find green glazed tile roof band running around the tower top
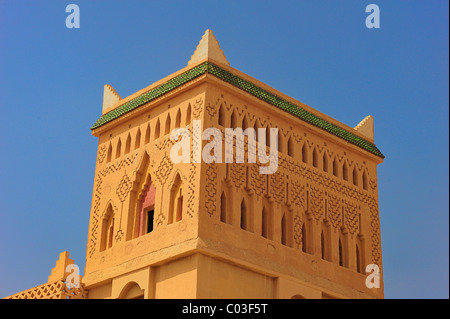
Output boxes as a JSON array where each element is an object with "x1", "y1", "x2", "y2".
[{"x1": 91, "y1": 62, "x2": 384, "y2": 158}]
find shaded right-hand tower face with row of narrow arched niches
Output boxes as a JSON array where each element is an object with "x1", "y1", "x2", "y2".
[{"x1": 199, "y1": 85, "x2": 383, "y2": 297}]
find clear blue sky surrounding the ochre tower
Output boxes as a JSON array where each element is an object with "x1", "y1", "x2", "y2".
[{"x1": 0, "y1": 0, "x2": 449, "y2": 298}]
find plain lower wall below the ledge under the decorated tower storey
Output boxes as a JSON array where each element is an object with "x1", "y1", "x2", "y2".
[{"x1": 86, "y1": 253, "x2": 360, "y2": 299}]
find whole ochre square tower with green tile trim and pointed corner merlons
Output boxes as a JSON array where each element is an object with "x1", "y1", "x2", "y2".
[{"x1": 83, "y1": 30, "x2": 384, "y2": 298}]
